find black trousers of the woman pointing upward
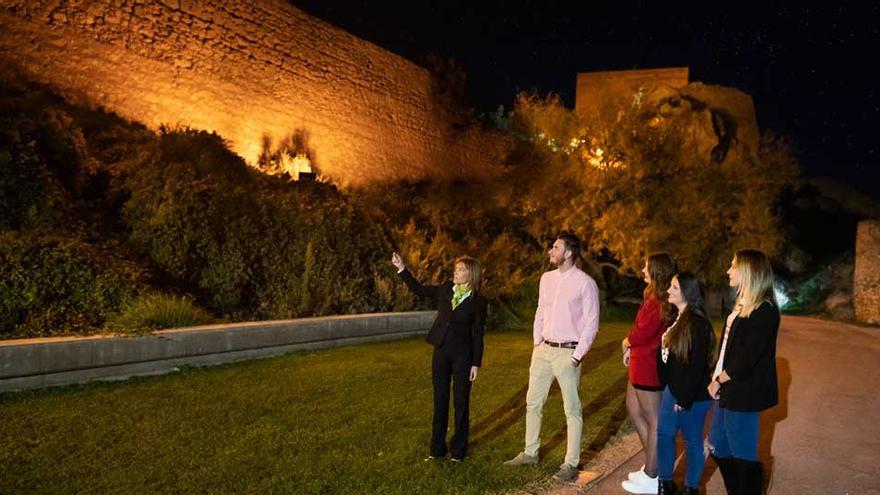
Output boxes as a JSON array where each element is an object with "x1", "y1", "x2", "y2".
[{"x1": 431, "y1": 343, "x2": 471, "y2": 459}]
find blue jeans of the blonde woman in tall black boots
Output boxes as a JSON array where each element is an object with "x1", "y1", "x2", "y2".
[{"x1": 709, "y1": 401, "x2": 761, "y2": 462}]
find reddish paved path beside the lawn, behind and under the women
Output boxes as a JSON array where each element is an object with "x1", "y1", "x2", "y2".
[{"x1": 559, "y1": 316, "x2": 880, "y2": 495}]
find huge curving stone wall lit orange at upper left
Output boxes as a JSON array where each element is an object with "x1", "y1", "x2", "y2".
[{"x1": 0, "y1": 0, "x2": 491, "y2": 185}]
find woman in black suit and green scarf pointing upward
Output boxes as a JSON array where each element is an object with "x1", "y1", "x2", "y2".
[{"x1": 391, "y1": 253, "x2": 487, "y2": 462}]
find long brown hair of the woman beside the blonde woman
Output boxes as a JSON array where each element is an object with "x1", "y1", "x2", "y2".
[{"x1": 663, "y1": 272, "x2": 715, "y2": 367}]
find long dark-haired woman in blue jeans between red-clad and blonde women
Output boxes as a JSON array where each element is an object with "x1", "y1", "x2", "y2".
[{"x1": 657, "y1": 272, "x2": 715, "y2": 495}]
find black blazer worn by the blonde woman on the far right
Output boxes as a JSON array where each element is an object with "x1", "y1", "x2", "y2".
[{"x1": 719, "y1": 301, "x2": 779, "y2": 412}]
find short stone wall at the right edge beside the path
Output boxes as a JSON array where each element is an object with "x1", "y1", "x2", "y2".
[{"x1": 853, "y1": 220, "x2": 880, "y2": 325}]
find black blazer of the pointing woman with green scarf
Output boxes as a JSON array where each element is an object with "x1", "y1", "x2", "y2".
[{"x1": 399, "y1": 269, "x2": 487, "y2": 366}]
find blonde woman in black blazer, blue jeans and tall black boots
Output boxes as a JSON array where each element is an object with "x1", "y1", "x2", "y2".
[{"x1": 708, "y1": 249, "x2": 780, "y2": 495}]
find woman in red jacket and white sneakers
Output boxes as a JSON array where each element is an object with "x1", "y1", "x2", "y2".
[{"x1": 621, "y1": 253, "x2": 677, "y2": 493}]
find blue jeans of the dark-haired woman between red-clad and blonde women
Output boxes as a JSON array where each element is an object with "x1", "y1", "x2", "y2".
[{"x1": 657, "y1": 387, "x2": 712, "y2": 488}]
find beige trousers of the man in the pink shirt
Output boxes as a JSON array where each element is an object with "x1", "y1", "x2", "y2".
[{"x1": 525, "y1": 344, "x2": 584, "y2": 467}]
